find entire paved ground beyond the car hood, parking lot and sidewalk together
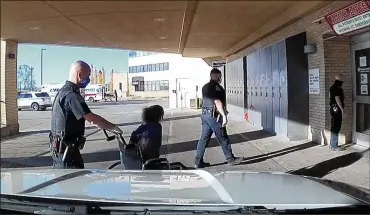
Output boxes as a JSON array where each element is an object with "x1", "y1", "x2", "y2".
[{"x1": 1, "y1": 100, "x2": 370, "y2": 188}]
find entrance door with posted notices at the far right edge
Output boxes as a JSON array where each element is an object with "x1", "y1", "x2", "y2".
[{"x1": 351, "y1": 32, "x2": 370, "y2": 147}]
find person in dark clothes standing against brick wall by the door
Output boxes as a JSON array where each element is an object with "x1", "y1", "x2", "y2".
[{"x1": 329, "y1": 75, "x2": 344, "y2": 151}]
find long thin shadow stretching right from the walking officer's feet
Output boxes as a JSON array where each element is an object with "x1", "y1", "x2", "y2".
[{"x1": 211, "y1": 142, "x2": 317, "y2": 166}]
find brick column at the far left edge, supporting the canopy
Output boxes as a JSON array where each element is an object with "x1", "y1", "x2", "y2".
[{"x1": 0, "y1": 40, "x2": 19, "y2": 137}]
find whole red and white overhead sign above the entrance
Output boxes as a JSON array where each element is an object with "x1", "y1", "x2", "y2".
[{"x1": 325, "y1": 0, "x2": 370, "y2": 35}]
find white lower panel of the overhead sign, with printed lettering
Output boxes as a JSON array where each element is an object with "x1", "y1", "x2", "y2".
[{"x1": 333, "y1": 11, "x2": 370, "y2": 34}]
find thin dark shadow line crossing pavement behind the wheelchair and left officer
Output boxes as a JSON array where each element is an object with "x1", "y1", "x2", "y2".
[{"x1": 1, "y1": 114, "x2": 200, "y2": 141}]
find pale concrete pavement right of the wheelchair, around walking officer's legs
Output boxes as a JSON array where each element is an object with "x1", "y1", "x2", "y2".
[{"x1": 166, "y1": 112, "x2": 370, "y2": 188}]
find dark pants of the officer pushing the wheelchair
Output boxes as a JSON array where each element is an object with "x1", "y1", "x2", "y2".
[{"x1": 51, "y1": 143, "x2": 84, "y2": 169}]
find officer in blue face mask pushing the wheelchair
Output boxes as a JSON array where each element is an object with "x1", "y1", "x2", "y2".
[{"x1": 49, "y1": 61, "x2": 123, "y2": 169}]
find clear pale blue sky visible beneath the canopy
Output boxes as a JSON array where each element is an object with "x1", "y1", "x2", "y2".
[{"x1": 17, "y1": 44, "x2": 128, "y2": 86}]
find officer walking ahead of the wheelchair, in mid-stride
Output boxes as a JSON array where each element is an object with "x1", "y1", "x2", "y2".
[{"x1": 195, "y1": 68, "x2": 243, "y2": 168}]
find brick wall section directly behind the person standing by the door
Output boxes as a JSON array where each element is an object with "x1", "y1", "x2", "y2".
[{"x1": 324, "y1": 37, "x2": 352, "y2": 143}]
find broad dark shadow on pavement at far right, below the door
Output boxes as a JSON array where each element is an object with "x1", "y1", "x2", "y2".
[{"x1": 287, "y1": 149, "x2": 370, "y2": 178}]
